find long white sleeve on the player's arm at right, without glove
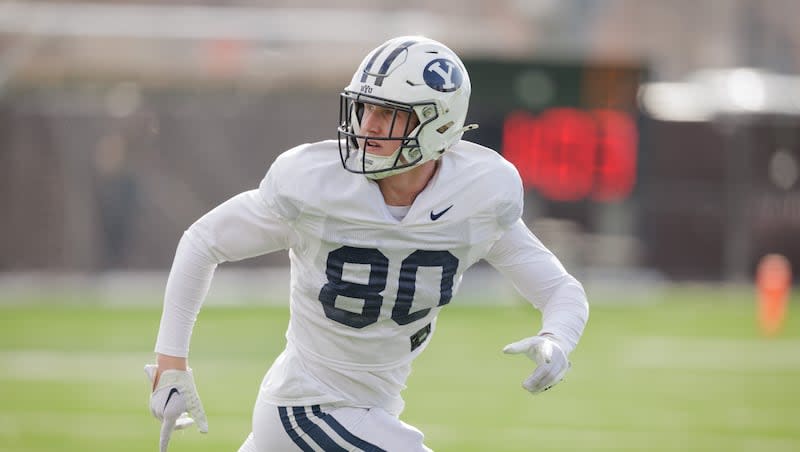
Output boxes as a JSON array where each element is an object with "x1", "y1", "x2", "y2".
[{"x1": 486, "y1": 219, "x2": 589, "y2": 354}]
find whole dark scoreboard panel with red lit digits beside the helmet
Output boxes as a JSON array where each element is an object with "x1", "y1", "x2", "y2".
[{"x1": 465, "y1": 60, "x2": 644, "y2": 202}]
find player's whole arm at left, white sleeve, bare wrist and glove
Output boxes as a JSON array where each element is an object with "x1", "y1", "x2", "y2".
[{"x1": 145, "y1": 190, "x2": 292, "y2": 452}]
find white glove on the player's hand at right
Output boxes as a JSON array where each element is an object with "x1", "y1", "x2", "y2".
[{"x1": 503, "y1": 335, "x2": 570, "y2": 394}]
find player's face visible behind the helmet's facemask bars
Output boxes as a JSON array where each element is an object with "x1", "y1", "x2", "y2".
[{"x1": 358, "y1": 104, "x2": 419, "y2": 156}]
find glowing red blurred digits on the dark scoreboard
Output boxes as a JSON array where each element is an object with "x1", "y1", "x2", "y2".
[{"x1": 501, "y1": 107, "x2": 638, "y2": 201}]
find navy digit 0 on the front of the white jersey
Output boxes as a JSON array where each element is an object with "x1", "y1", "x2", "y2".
[{"x1": 392, "y1": 250, "x2": 458, "y2": 325}]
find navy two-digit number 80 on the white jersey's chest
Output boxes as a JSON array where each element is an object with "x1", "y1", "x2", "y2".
[{"x1": 319, "y1": 246, "x2": 458, "y2": 328}]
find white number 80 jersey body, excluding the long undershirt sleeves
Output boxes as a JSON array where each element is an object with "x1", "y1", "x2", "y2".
[{"x1": 259, "y1": 141, "x2": 522, "y2": 410}]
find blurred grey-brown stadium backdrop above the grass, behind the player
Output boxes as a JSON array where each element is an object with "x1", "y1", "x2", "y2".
[{"x1": 0, "y1": 0, "x2": 800, "y2": 296}]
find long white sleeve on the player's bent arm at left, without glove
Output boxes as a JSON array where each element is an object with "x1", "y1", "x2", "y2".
[{"x1": 155, "y1": 190, "x2": 293, "y2": 357}]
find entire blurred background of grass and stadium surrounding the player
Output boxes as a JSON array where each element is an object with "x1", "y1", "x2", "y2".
[{"x1": 0, "y1": 0, "x2": 800, "y2": 452}]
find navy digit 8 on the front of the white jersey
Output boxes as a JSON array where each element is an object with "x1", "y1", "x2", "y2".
[{"x1": 319, "y1": 246, "x2": 389, "y2": 328}]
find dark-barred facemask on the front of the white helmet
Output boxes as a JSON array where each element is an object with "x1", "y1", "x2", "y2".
[{"x1": 338, "y1": 91, "x2": 436, "y2": 179}]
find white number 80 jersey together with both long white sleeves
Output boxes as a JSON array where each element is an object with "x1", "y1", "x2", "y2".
[{"x1": 156, "y1": 140, "x2": 585, "y2": 414}]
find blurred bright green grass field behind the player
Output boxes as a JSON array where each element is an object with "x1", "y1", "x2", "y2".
[{"x1": 0, "y1": 288, "x2": 800, "y2": 452}]
